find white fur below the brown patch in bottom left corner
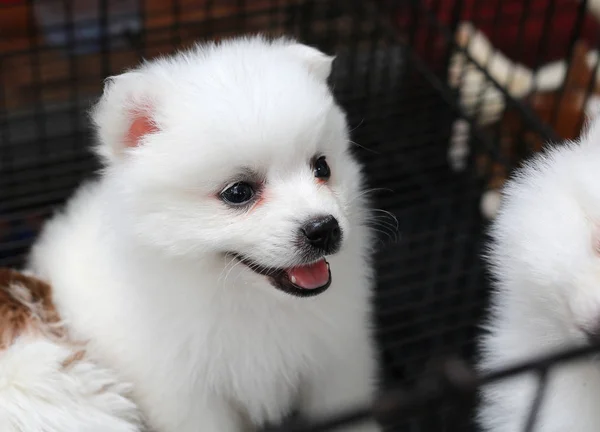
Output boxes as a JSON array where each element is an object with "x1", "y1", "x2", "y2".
[{"x1": 0, "y1": 336, "x2": 142, "y2": 432}]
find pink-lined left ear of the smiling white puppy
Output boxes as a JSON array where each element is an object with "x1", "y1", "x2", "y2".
[{"x1": 92, "y1": 72, "x2": 160, "y2": 163}]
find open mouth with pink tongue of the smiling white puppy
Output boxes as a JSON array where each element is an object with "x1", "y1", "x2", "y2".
[{"x1": 235, "y1": 255, "x2": 331, "y2": 297}]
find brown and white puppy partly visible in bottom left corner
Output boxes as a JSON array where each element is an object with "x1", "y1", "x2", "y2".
[{"x1": 0, "y1": 269, "x2": 141, "y2": 432}]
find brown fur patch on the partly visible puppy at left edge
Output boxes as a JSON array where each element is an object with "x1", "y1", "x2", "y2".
[{"x1": 0, "y1": 269, "x2": 66, "y2": 350}]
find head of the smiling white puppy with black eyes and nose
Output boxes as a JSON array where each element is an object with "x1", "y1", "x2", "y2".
[{"x1": 93, "y1": 38, "x2": 361, "y2": 295}]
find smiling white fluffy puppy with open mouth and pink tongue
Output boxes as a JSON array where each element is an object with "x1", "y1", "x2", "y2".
[{"x1": 30, "y1": 37, "x2": 377, "y2": 432}]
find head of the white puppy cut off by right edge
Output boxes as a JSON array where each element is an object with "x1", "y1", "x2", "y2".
[{"x1": 490, "y1": 121, "x2": 600, "y2": 343}]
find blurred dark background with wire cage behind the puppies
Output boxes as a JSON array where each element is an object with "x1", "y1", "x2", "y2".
[{"x1": 0, "y1": 0, "x2": 600, "y2": 432}]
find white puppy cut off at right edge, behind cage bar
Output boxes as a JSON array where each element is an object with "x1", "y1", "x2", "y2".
[{"x1": 479, "y1": 120, "x2": 600, "y2": 432}]
